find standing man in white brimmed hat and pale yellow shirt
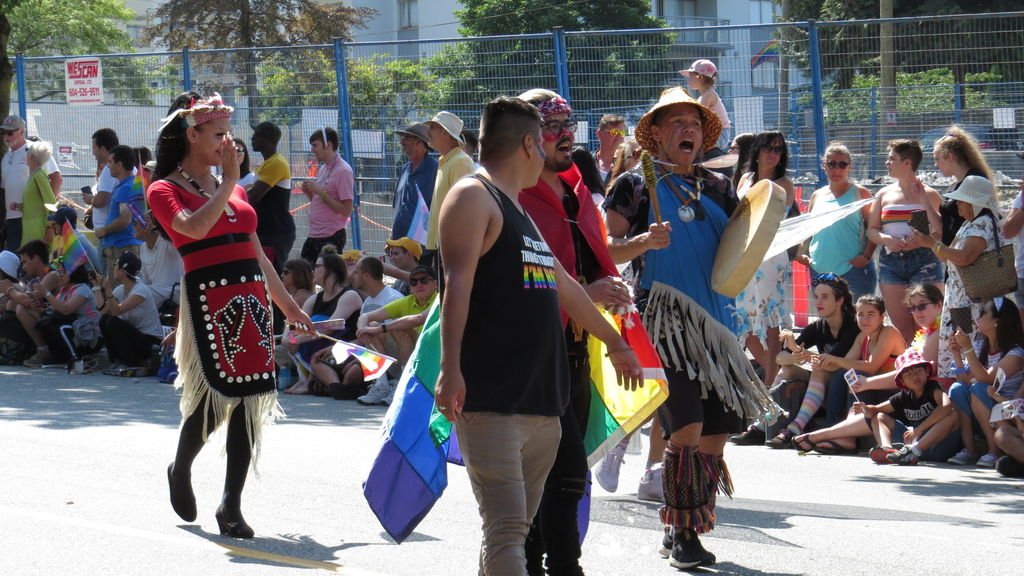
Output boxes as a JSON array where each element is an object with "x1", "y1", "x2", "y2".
[{"x1": 427, "y1": 112, "x2": 473, "y2": 265}]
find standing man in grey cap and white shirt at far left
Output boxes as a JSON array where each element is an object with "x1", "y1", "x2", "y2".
[{"x1": 0, "y1": 115, "x2": 62, "y2": 251}]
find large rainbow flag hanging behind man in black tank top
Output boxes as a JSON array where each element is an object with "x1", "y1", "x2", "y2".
[{"x1": 362, "y1": 302, "x2": 668, "y2": 542}]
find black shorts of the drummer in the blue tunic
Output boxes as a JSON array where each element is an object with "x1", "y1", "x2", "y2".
[{"x1": 657, "y1": 366, "x2": 744, "y2": 440}]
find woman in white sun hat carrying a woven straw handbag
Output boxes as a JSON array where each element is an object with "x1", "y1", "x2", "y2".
[{"x1": 913, "y1": 175, "x2": 1017, "y2": 378}]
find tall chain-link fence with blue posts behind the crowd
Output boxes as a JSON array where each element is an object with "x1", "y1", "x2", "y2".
[{"x1": 8, "y1": 12, "x2": 1024, "y2": 254}]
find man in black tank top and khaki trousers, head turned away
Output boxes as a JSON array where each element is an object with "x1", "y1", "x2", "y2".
[{"x1": 435, "y1": 97, "x2": 641, "y2": 575}]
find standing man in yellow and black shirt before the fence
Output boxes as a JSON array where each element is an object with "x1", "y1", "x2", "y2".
[{"x1": 249, "y1": 122, "x2": 294, "y2": 274}]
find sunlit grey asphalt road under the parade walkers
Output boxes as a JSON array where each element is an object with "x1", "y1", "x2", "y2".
[{"x1": 0, "y1": 368, "x2": 1024, "y2": 576}]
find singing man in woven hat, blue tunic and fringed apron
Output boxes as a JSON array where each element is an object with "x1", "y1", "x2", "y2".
[{"x1": 605, "y1": 87, "x2": 773, "y2": 569}]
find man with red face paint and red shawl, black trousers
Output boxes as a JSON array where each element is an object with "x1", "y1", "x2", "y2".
[{"x1": 519, "y1": 89, "x2": 633, "y2": 574}]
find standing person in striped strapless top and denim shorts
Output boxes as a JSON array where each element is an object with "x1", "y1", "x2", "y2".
[{"x1": 867, "y1": 140, "x2": 945, "y2": 342}]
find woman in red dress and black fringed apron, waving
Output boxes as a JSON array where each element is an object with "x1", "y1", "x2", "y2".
[{"x1": 146, "y1": 92, "x2": 311, "y2": 538}]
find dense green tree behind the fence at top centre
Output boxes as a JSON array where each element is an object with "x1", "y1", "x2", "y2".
[{"x1": 427, "y1": 0, "x2": 674, "y2": 115}]
